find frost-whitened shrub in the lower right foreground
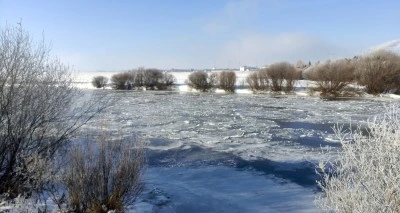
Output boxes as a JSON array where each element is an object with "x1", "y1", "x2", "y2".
[{"x1": 317, "y1": 106, "x2": 400, "y2": 212}]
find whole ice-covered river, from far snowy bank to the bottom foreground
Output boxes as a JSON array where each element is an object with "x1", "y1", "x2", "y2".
[{"x1": 80, "y1": 90, "x2": 390, "y2": 212}]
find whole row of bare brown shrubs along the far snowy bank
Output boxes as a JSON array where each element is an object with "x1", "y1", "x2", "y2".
[{"x1": 92, "y1": 50, "x2": 400, "y2": 98}]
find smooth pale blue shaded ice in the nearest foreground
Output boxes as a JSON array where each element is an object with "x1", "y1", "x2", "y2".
[{"x1": 132, "y1": 166, "x2": 318, "y2": 213}]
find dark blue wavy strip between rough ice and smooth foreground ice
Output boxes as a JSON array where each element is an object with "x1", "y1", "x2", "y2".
[{"x1": 148, "y1": 146, "x2": 318, "y2": 189}]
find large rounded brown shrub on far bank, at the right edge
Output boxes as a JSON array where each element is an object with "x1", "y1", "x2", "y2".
[{"x1": 356, "y1": 51, "x2": 400, "y2": 95}]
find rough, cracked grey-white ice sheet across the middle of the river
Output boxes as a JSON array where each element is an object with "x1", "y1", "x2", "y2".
[{"x1": 82, "y1": 91, "x2": 388, "y2": 161}]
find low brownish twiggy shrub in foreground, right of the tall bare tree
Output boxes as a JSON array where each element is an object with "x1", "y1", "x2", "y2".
[{"x1": 62, "y1": 135, "x2": 144, "y2": 213}]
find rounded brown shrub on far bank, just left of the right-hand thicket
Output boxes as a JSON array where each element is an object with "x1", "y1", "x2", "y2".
[{"x1": 266, "y1": 62, "x2": 300, "y2": 92}]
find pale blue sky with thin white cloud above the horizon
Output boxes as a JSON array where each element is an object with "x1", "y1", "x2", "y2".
[{"x1": 0, "y1": 0, "x2": 400, "y2": 71}]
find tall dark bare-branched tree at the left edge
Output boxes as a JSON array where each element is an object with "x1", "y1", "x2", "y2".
[{"x1": 0, "y1": 26, "x2": 106, "y2": 198}]
